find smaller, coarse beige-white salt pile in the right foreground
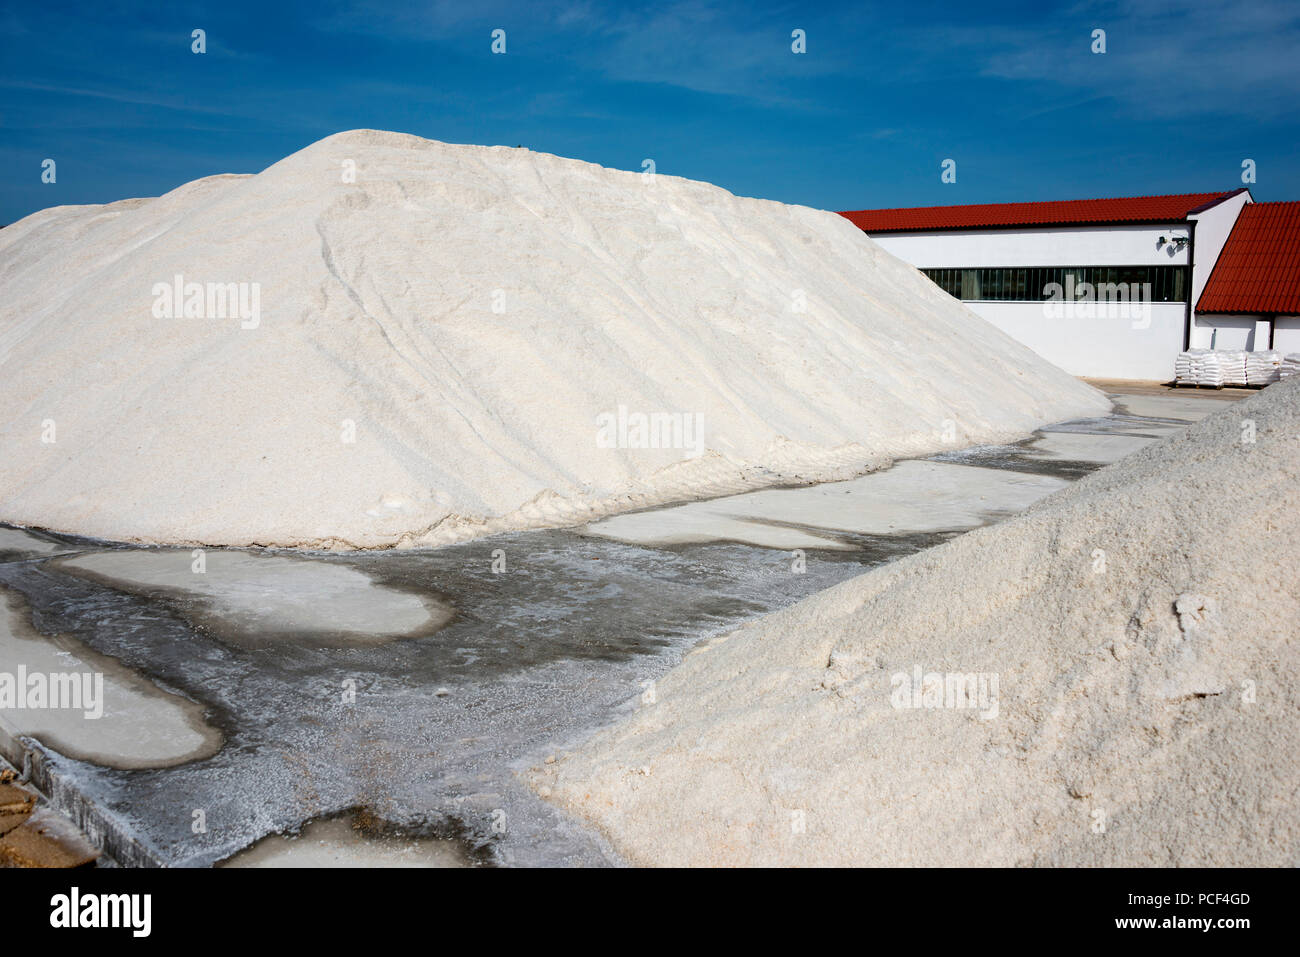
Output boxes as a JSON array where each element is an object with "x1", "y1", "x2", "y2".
[{"x1": 532, "y1": 381, "x2": 1300, "y2": 866}]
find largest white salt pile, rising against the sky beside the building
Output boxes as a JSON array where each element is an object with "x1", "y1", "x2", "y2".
[{"x1": 0, "y1": 130, "x2": 1109, "y2": 546}]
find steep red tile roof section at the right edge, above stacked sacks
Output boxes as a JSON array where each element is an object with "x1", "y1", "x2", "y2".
[{"x1": 1196, "y1": 203, "x2": 1300, "y2": 316}]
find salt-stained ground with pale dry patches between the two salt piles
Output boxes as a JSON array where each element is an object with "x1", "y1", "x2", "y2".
[{"x1": 0, "y1": 395, "x2": 1184, "y2": 866}]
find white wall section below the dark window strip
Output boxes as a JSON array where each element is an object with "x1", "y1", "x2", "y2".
[{"x1": 966, "y1": 302, "x2": 1190, "y2": 382}]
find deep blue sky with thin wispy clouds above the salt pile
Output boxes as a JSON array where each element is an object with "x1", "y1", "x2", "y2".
[{"x1": 0, "y1": 0, "x2": 1300, "y2": 222}]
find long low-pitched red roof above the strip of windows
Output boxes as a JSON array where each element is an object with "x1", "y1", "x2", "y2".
[{"x1": 840, "y1": 190, "x2": 1240, "y2": 234}]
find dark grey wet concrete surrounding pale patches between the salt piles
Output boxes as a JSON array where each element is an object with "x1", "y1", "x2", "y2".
[{"x1": 0, "y1": 390, "x2": 1232, "y2": 866}]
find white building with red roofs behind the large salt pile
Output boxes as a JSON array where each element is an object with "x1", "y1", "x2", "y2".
[{"x1": 840, "y1": 187, "x2": 1300, "y2": 381}]
